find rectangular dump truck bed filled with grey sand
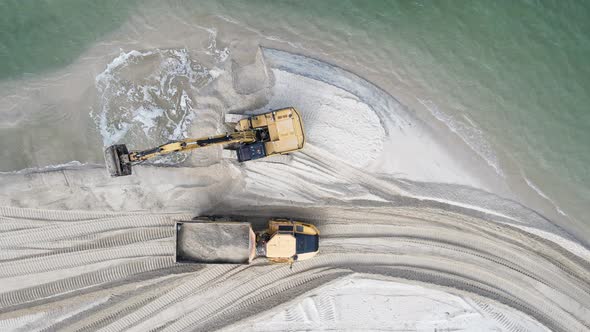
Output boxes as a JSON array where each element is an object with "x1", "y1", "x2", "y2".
[{"x1": 176, "y1": 221, "x2": 256, "y2": 264}]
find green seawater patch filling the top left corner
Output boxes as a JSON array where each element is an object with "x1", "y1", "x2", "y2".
[{"x1": 0, "y1": 0, "x2": 134, "y2": 79}]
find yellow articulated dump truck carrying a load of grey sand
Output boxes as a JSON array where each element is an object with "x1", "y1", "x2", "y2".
[{"x1": 175, "y1": 217, "x2": 320, "y2": 264}]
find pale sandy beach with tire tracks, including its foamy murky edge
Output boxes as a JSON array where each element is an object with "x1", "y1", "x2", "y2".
[{"x1": 0, "y1": 3, "x2": 590, "y2": 331}]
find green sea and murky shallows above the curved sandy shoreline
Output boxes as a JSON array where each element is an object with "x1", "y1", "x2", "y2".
[{"x1": 0, "y1": 1, "x2": 590, "y2": 233}]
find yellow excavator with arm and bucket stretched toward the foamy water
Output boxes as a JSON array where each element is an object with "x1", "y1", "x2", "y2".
[{"x1": 105, "y1": 107, "x2": 305, "y2": 177}]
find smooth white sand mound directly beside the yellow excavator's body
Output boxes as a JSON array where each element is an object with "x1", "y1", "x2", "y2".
[{"x1": 265, "y1": 69, "x2": 385, "y2": 167}]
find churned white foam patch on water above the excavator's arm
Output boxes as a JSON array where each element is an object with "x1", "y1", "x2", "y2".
[{"x1": 96, "y1": 48, "x2": 216, "y2": 146}]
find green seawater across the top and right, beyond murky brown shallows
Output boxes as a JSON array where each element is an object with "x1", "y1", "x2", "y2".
[{"x1": 0, "y1": 0, "x2": 590, "y2": 226}]
